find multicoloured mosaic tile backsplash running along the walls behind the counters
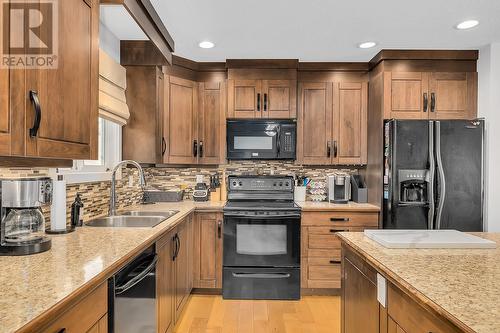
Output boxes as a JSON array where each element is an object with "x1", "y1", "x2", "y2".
[{"x1": 0, "y1": 161, "x2": 357, "y2": 226}]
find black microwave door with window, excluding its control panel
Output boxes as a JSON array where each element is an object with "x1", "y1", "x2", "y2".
[{"x1": 227, "y1": 120, "x2": 279, "y2": 160}]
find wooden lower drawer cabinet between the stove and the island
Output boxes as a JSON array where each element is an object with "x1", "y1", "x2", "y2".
[{"x1": 301, "y1": 211, "x2": 378, "y2": 292}]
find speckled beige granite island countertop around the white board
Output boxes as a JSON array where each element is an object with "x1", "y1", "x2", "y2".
[{"x1": 338, "y1": 232, "x2": 500, "y2": 333}]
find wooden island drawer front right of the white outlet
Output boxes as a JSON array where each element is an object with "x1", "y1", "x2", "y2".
[{"x1": 387, "y1": 284, "x2": 461, "y2": 333}]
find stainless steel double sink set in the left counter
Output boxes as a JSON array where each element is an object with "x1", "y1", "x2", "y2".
[{"x1": 85, "y1": 210, "x2": 179, "y2": 228}]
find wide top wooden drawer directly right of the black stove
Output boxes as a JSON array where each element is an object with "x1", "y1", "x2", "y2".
[{"x1": 302, "y1": 211, "x2": 378, "y2": 226}]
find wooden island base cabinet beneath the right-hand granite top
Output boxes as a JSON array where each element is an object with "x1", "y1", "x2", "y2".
[{"x1": 341, "y1": 244, "x2": 463, "y2": 333}]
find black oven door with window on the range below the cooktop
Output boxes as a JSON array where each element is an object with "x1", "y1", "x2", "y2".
[{"x1": 224, "y1": 213, "x2": 300, "y2": 267}]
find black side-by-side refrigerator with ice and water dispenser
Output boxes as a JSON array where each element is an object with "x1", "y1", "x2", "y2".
[{"x1": 383, "y1": 120, "x2": 484, "y2": 231}]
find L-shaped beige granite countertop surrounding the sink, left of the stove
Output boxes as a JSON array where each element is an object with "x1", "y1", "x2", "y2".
[{"x1": 0, "y1": 201, "x2": 224, "y2": 333}]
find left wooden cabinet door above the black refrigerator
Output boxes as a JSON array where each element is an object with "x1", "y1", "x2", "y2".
[{"x1": 384, "y1": 72, "x2": 430, "y2": 119}]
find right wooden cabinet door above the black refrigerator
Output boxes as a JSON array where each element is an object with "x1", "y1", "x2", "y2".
[{"x1": 429, "y1": 73, "x2": 477, "y2": 119}]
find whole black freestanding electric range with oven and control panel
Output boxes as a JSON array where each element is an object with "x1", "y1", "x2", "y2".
[{"x1": 222, "y1": 176, "x2": 300, "y2": 299}]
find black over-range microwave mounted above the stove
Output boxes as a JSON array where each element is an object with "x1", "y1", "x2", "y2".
[{"x1": 227, "y1": 119, "x2": 297, "y2": 160}]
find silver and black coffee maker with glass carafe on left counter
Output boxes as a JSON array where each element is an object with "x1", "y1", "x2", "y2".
[{"x1": 0, "y1": 178, "x2": 52, "y2": 255}]
